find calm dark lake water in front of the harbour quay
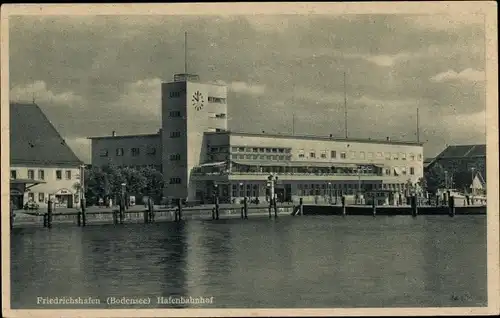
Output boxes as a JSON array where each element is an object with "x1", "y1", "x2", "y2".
[{"x1": 11, "y1": 216, "x2": 487, "y2": 309}]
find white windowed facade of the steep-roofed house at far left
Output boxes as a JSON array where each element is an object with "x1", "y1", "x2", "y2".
[{"x1": 10, "y1": 166, "x2": 80, "y2": 208}]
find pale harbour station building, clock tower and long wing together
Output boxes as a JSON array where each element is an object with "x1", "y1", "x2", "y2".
[{"x1": 88, "y1": 74, "x2": 423, "y2": 202}]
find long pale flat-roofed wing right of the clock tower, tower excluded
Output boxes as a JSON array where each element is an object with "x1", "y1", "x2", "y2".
[{"x1": 191, "y1": 132, "x2": 423, "y2": 201}]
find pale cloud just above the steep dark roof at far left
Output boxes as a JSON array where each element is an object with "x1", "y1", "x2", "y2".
[{"x1": 10, "y1": 81, "x2": 83, "y2": 106}]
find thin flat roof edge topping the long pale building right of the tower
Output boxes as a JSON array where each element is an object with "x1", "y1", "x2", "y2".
[{"x1": 205, "y1": 131, "x2": 424, "y2": 146}]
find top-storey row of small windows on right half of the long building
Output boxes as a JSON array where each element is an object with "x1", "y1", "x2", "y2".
[{"x1": 298, "y1": 149, "x2": 422, "y2": 161}]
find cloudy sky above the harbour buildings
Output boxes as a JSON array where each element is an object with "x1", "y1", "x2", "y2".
[{"x1": 9, "y1": 11, "x2": 485, "y2": 162}]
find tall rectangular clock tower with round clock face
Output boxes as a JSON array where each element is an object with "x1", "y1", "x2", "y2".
[{"x1": 162, "y1": 74, "x2": 227, "y2": 201}]
